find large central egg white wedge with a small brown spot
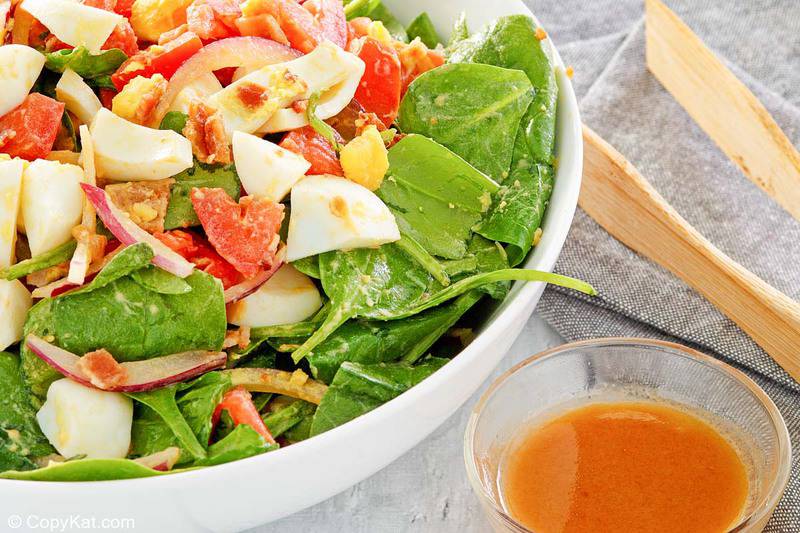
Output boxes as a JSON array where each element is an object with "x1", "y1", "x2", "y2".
[{"x1": 286, "y1": 176, "x2": 400, "y2": 261}]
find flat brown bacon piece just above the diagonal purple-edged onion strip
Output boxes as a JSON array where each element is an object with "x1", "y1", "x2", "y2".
[{"x1": 106, "y1": 178, "x2": 175, "y2": 233}]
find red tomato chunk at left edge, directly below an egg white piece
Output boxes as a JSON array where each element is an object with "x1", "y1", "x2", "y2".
[{"x1": 0, "y1": 93, "x2": 64, "y2": 161}]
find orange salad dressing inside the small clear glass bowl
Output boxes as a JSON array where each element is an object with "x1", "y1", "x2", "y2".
[{"x1": 501, "y1": 402, "x2": 748, "y2": 533}]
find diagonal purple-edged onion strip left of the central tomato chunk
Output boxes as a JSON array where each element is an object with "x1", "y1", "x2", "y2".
[{"x1": 81, "y1": 183, "x2": 194, "y2": 278}]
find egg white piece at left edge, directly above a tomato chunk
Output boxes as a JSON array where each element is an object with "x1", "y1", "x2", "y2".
[{"x1": 0, "y1": 44, "x2": 45, "y2": 116}]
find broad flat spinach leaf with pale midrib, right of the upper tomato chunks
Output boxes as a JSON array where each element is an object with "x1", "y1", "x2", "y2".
[{"x1": 397, "y1": 63, "x2": 538, "y2": 182}]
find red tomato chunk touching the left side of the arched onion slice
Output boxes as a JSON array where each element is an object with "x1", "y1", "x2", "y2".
[{"x1": 111, "y1": 32, "x2": 203, "y2": 91}]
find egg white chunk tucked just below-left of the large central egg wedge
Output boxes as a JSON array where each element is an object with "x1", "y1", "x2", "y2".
[{"x1": 228, "y1": 264, "x2": 322, "y2": 328}]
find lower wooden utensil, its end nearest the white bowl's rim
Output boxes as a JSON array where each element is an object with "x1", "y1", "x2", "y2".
[{"x1": 579, "y1": 126, "x2": 800, "y2": 381}]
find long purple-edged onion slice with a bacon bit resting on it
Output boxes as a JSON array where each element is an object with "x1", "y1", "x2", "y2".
[{"x1": 25, "y1": 335, "x2": 228, "y2": 392}]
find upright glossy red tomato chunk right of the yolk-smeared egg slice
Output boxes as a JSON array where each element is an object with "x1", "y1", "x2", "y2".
[{"x1": 355, "y1": 37, "x2": 402, "y2": 128}]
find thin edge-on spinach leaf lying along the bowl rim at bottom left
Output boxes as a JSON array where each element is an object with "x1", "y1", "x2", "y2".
[{"x1": 0, "y1": 459, "x2": 189, "y2": 481}]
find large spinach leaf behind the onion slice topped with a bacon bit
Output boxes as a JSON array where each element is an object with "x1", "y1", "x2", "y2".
[{"x1": 21, "y1": 244, "x2": 227, "y2": 397}]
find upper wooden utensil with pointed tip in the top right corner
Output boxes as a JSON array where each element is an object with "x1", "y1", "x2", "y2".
[{"x1": 645, "y1": 0, "x2": 800, "y2": 220}]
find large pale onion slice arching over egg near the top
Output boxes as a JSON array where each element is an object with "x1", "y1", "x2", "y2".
[{"x1": 151, "y1": 37, "x2": 302, "y2": 127}]
